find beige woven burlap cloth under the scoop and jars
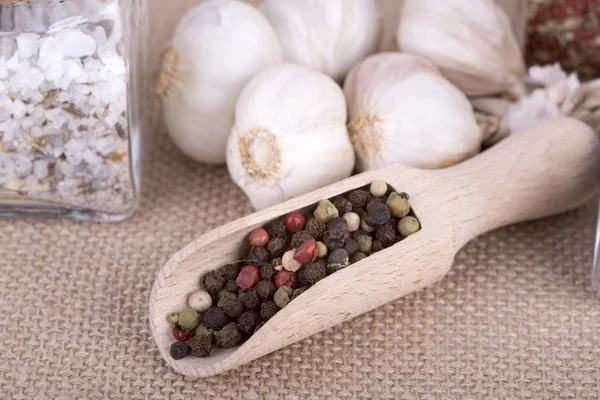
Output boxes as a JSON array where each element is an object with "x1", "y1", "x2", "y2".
[{"x1": 0, "y1": 0, "x2": 600, "y2": 400}]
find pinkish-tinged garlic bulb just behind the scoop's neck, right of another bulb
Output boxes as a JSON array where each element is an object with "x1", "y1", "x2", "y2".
[{"x1": 344, "y1": 53, "x2": 482, "y2": 171}]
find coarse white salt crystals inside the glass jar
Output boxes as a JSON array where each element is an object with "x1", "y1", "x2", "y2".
[{"x1": 0, "y1": 9, "x2": 135, "y2": 213}]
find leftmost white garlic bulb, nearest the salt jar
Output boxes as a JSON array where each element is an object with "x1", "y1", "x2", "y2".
[{"x1": 156, "y1": 0, "x2": 283, "y2": 163}]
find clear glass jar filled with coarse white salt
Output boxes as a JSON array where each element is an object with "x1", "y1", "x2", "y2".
[{"x1": 0, "y1": 0, "x2": 147, "y2": 221}]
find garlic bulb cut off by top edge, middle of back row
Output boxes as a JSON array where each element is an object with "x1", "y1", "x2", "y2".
[{"x1": 261, "y1": 0, "x2": 379, "y2": 82}]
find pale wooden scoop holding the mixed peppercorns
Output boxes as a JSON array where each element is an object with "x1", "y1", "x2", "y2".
[{"x1": 149, "y1": 119, "x2": 600, "y2": 377}]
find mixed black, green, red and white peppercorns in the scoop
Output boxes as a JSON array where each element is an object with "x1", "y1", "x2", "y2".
[{"x1": 167, "y1": 181, "x2": 421, "y2": 360}]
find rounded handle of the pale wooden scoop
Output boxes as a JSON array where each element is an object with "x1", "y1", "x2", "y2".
[{"x1": 440, "y1": 118, "x2": 600, "y2": 248}]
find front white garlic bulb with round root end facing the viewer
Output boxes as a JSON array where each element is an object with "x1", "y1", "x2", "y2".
[{"x1": 227, "y1": 64, "x2": 354, "y2": 209}]
